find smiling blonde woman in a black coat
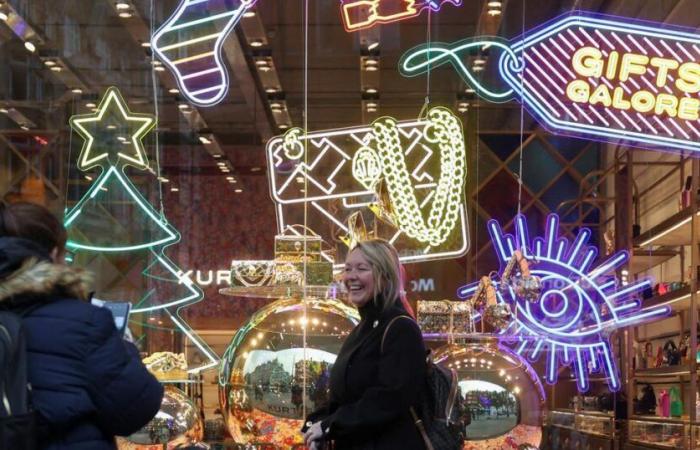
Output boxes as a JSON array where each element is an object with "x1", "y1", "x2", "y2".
[{"x1": 302, "y1": 239, "x2": 426, "y2": 450}]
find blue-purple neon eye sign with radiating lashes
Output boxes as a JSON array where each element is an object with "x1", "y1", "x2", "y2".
[{"x1": 458, "y1": 214, "x2": 670, "y2": 392}]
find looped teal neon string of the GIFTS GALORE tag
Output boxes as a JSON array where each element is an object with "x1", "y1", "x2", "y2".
[{"x1": 399, "y1": 38, "x2": 524, "y2": 103}]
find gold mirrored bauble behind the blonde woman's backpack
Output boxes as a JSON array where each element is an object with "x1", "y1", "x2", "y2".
[{"x1": 433, "y1": 335, "x2": 546, "y2": 450}]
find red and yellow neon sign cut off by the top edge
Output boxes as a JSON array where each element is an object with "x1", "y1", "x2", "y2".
[{"x1": 340, "y1": 0, "x2": 462, "y2": 32}]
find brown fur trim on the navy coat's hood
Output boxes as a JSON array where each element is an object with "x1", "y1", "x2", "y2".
[{"x1": 0, "y1": 258, "x2": 92, "y2": 304}]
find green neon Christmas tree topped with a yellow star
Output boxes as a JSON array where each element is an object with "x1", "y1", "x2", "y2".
[{"x1": 64, "y1": 87, "x2": 218, "y2": 372}]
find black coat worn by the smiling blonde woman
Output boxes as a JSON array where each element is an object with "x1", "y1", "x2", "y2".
[{"x1": 307, "y1": 302, "x2": 425, "y2": 450}]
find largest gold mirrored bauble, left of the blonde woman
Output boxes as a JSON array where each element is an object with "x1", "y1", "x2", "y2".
[{"x1": 219, "y1": 298, "x2": 359, "y2": 448}]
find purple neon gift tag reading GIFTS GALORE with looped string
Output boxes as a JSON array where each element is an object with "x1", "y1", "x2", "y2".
[{"x1": 400, "y1": 13, "x2": 700, "y2": 152}]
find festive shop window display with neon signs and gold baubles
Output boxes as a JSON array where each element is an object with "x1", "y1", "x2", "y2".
[{"x1": 0, "y1": 0, "x2": 700, "y2": 450}]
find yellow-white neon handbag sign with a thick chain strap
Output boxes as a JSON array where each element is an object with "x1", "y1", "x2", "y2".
[{"x1": 267, "y1": 107, "x2": 468, "y2": 267}]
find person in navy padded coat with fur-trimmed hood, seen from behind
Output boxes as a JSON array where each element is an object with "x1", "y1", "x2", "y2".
[{"x1": 0, "y1": 203, "x2": 163, "y2": 450}]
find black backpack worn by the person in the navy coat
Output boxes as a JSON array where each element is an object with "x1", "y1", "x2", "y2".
[{"x1": 0, "y1": 311, "x2": 37, "y2": 450}]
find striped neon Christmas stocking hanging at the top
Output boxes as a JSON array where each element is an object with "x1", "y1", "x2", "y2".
[{"x1": 151, "y1": 0, "x2": 257, "y2": 106}]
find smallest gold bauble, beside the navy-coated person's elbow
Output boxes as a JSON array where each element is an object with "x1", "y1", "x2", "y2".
[{"x1": 117, "y1": 385, "x2": 204, "y2": 450}]
